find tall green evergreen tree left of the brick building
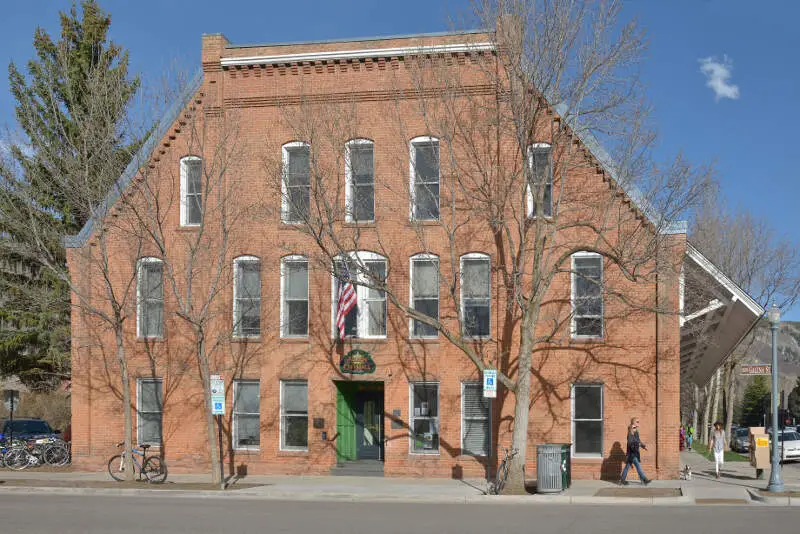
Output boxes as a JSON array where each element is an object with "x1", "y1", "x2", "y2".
[{"x1": 0, "y1": 0, "x2": 140, "y2": 392}]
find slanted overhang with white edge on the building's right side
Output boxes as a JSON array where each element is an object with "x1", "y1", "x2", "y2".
[{"x1": 680, "y1": 243, "x2": 764, "y2": 386}]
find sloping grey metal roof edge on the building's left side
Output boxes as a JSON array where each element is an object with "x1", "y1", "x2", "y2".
[{"x1": 62, "y1": 69, "x2": 203, "y2": 248}]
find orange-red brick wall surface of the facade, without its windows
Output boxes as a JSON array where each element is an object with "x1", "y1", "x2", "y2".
[{"x1": 68, "y1": 30, "x2": 685, "y2": 478}]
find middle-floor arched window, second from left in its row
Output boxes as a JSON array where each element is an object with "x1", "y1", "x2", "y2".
[{"x1": 233, "y1": 256, "x2": 261, "y2": 337}]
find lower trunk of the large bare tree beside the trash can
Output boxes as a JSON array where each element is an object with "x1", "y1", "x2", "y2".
[{"x1": 503, "y1": 304, "x2": 538, "y2": 495}]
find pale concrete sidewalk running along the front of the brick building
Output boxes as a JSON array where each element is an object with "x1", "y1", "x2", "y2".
[{"x1": 0, "y1": 452, "x2": 800, "y2": 505}]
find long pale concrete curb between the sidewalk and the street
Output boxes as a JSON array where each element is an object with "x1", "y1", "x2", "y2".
[{"x1": 0, "y1": 486, "x2": 694, "y2": 506}]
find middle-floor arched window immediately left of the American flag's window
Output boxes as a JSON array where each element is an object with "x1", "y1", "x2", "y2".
[{"x1": 281, "y1": 256, "x2": 308, "y2": 337}]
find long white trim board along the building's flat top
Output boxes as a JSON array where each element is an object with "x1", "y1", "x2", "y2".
[{"x1": 220, "y1": 42, "x2": 497, "y2": 67}]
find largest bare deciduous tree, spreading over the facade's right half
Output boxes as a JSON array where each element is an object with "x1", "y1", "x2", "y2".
[{"x1": 265, "y1": 0, "x2": 712, "y2": 492}]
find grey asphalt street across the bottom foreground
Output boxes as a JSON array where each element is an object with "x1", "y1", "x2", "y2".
[{"x1": 0, "y1": 494, "x2": 800, "y2": 534}]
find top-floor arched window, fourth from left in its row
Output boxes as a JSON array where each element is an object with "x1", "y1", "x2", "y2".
[{"x1": 410, "y1": 137, "x2": 439, "y2": 221}]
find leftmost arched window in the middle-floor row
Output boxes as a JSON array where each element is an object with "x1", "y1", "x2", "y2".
[{"x1": 136, "y1": 258, "x2": 164, "y2": 338}]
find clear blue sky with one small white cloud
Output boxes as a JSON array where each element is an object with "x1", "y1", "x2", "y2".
[{"x1": 0, "y1": 0, "x2": 800, "y2": 320}]
